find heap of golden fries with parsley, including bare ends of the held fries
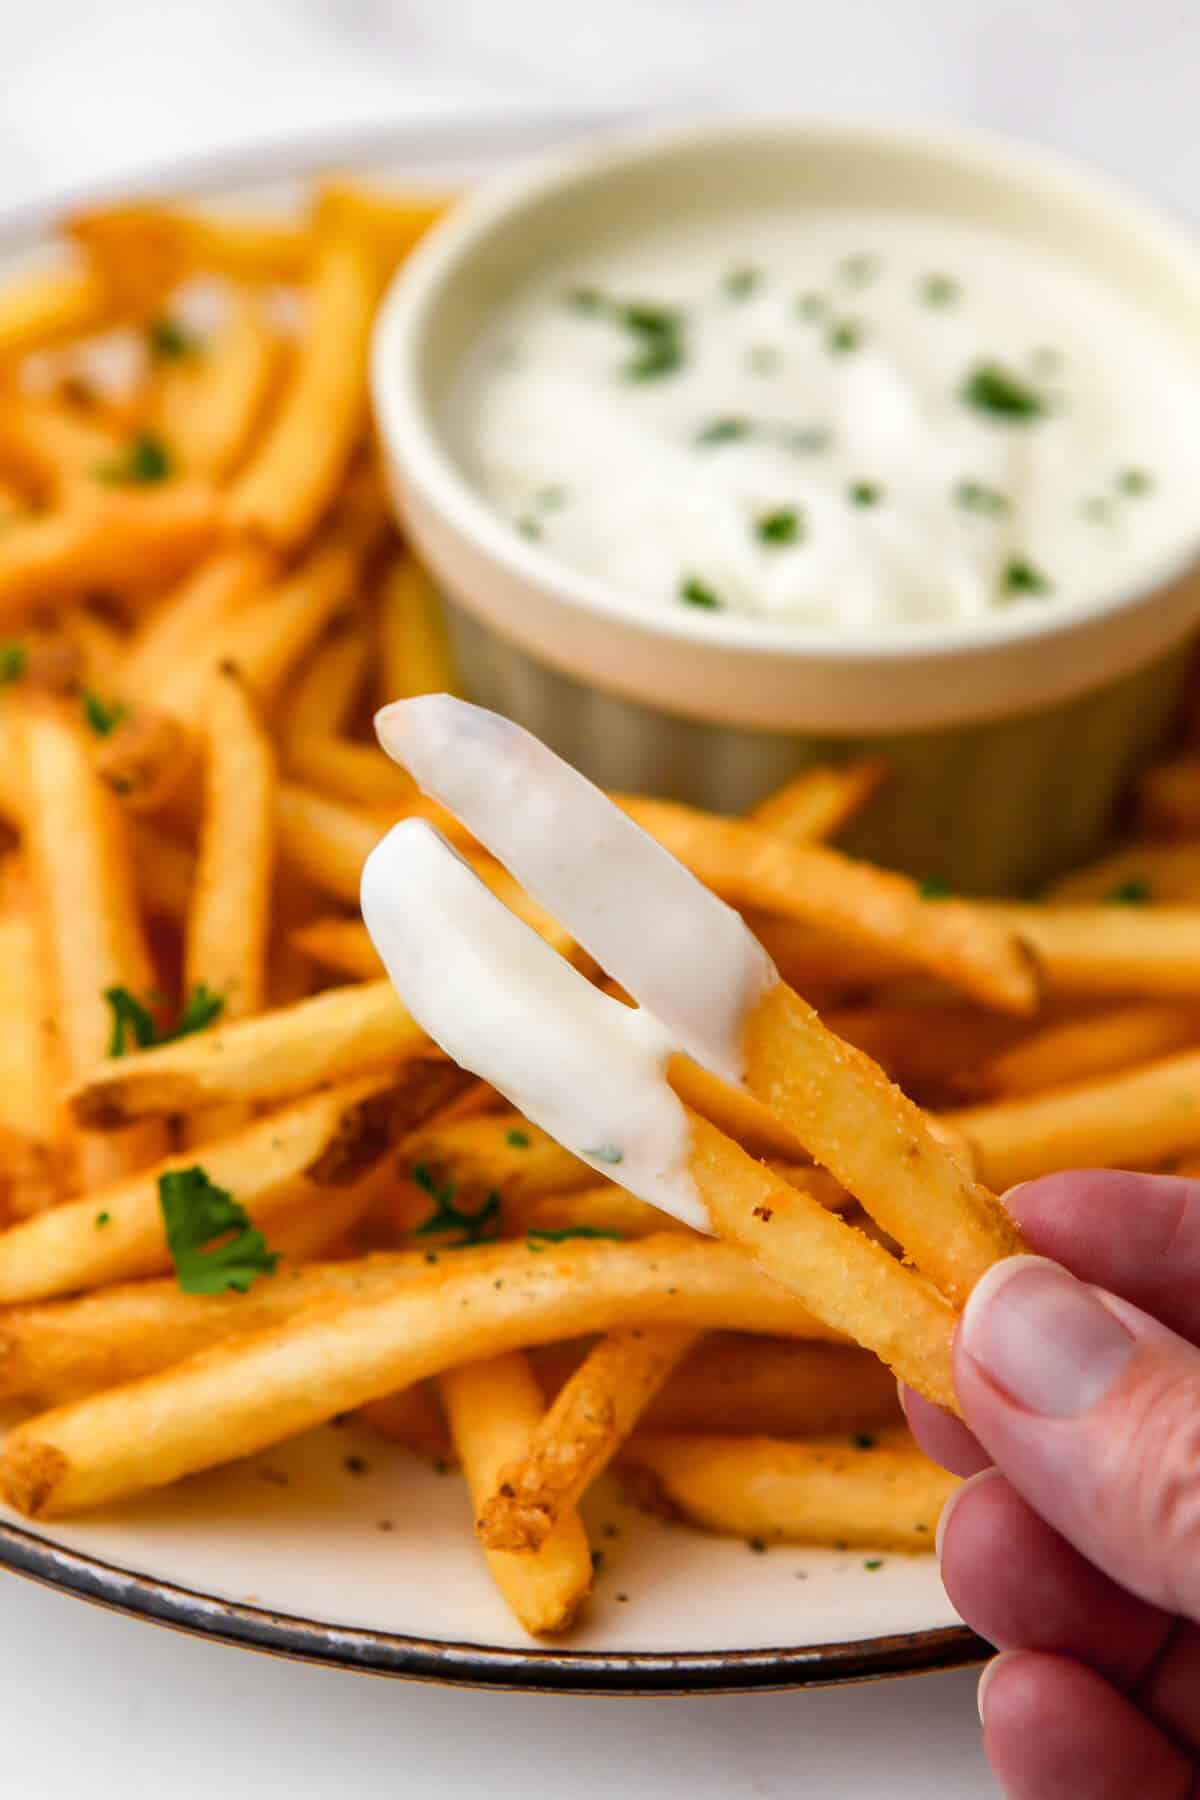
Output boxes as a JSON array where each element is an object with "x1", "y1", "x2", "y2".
[{"x1": 0, "y1": 180, "x2": 1200, "y2": 1633}]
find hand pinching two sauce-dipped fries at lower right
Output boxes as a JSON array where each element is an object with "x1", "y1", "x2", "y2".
[{"x1": 903, "y1": 1170, "x2": 1200, "y2": 1800}]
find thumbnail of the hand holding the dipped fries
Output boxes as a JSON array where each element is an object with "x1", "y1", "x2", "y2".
[{"x1": 959, "y1": 1256, "x2": 1137, "y2": 1418}]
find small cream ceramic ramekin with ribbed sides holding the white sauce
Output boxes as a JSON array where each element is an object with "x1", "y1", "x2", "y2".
[{"x1": 372, "y1": 122, "x2": 1200, "y2": 891}]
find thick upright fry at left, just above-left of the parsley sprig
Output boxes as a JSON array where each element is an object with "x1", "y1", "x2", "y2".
[{"x1": 16, "y1": 695, "x2": 164, "y2": 1183}]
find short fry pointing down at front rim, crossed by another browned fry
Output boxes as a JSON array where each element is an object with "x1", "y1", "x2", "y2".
[{"x1": 439, "y1": 1350, "x2": 592, "y2": 1636}]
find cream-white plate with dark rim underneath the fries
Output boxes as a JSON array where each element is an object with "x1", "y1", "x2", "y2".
[{"x1": 0, "y1": 115, "x2": 984, "y2": 1692}]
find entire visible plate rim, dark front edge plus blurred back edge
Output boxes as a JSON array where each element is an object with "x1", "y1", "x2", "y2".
[{"x1": 0, "y1": 108, "x2": 991, "y2": 1697}]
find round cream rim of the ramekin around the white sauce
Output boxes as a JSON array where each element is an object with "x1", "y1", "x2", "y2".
[{"x1": 371, "y1": 115, "x2": 1200, "y2": 670}]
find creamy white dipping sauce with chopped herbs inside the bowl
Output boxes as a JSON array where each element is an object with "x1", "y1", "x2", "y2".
[{"x1": 450, "y1": 209, "x2": 1200, "y2": 635}]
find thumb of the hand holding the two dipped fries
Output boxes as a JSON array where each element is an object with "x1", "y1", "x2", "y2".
[{"x1": 954, "y1": 1256, "x2": 1200, "y2": 1622}]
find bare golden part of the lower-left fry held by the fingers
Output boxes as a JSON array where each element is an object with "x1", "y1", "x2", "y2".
[{"x1": 689, "y1": 1114, "x2": 964, "y2": 1411}]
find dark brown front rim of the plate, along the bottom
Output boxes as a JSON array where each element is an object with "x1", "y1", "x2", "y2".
[{"x1": 0, "y1": 1521, "x2": 991, "y2": 1696}]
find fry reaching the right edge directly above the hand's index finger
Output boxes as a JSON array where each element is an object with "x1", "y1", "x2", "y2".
[{"x1": 948, "y1": 1051, "x2": 1200, "y2": 1190}]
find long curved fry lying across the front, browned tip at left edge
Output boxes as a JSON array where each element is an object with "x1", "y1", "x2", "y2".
[{"x1": 0, "y1": 1231, "x2": 845, "y2": 1517}]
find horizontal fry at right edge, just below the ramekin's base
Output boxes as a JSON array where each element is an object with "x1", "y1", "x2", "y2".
[{"x1": 984, "y1": 904, "x2": 1200, "y2": 999}]
